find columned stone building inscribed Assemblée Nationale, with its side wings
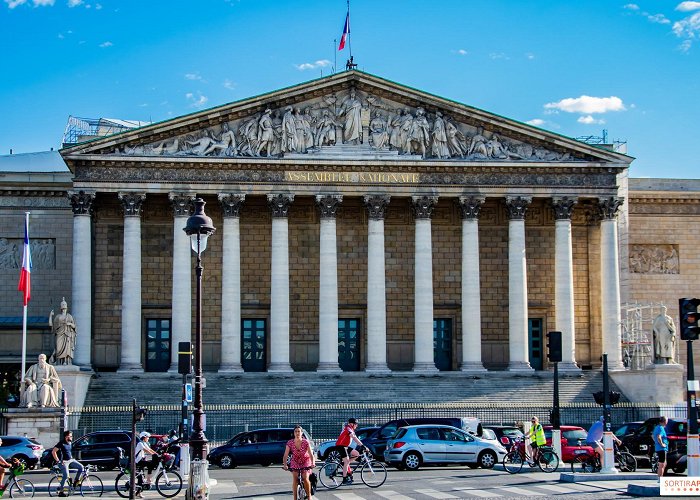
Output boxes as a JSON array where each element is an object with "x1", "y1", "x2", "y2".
[{"x1": 0, "y1": 71, "x2": 700, "y2": 382}]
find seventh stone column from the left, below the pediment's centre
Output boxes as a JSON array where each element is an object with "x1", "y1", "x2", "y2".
[{"x1": 364, "y1": 194, "x2": 391, "y2": 373}]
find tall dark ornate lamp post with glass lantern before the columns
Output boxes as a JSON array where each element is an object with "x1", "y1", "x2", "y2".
[{"x1": 184, "y1": 198, "x2": 216, "y2": 460}]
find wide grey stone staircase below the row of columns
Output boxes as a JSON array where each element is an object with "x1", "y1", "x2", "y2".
[{"x1": 85, "y1": 370, "x2": 626, "y2": 406}]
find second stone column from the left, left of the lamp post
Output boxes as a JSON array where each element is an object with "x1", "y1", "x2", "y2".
[{"x1": 118, "y1": 192, "x2": 146, "y2": 372}]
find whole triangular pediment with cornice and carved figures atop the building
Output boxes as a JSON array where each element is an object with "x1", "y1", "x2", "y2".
[{"x1": 62, "y1": 71, "x2": 631, "y2": 164}]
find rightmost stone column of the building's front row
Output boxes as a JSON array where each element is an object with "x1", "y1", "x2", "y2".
[{"x1": 598, "y1": 196, "x2": 625, "y2": 370}]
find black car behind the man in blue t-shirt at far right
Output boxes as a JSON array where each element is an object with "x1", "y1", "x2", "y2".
[{"x1": 622, "y1": 417, "x2": 688, "y2": 474}]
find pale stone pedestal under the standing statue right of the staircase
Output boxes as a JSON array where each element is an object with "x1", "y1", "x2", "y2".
[{"x1": 610, "y1": 365, "x2": 686, "y2": 403}]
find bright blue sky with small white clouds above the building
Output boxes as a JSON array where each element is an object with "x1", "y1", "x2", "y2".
[{"x1": 0, "y1": 0, "x2": 700, "y2": 178}]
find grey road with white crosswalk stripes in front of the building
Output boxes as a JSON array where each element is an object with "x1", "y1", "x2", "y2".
[{"x1": 21, "y1": 465, "x2": 655, "y2": 500}]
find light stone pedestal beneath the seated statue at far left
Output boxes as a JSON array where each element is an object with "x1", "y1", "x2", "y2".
[{"x1": 3, "y1": 408, "x2": 62, "y2": 448}]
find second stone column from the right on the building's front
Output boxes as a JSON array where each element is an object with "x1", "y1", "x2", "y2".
[{"x1": 552, "y1": 197, "x2": 580, "y2": 371}]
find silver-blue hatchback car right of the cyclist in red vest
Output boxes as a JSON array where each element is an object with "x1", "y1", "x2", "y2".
[{"x1": 384, "y1": 425, "x2": 506, "y2": 470}]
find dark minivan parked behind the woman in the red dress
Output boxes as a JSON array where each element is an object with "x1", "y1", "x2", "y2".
[{"x1": 207, "y1": 427, "x2": 313, "y2": 469}]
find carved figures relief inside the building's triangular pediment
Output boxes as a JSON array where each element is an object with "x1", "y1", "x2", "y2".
[{"x1": 113, "y1": 88, "x2": 578, "y2": 162}]
